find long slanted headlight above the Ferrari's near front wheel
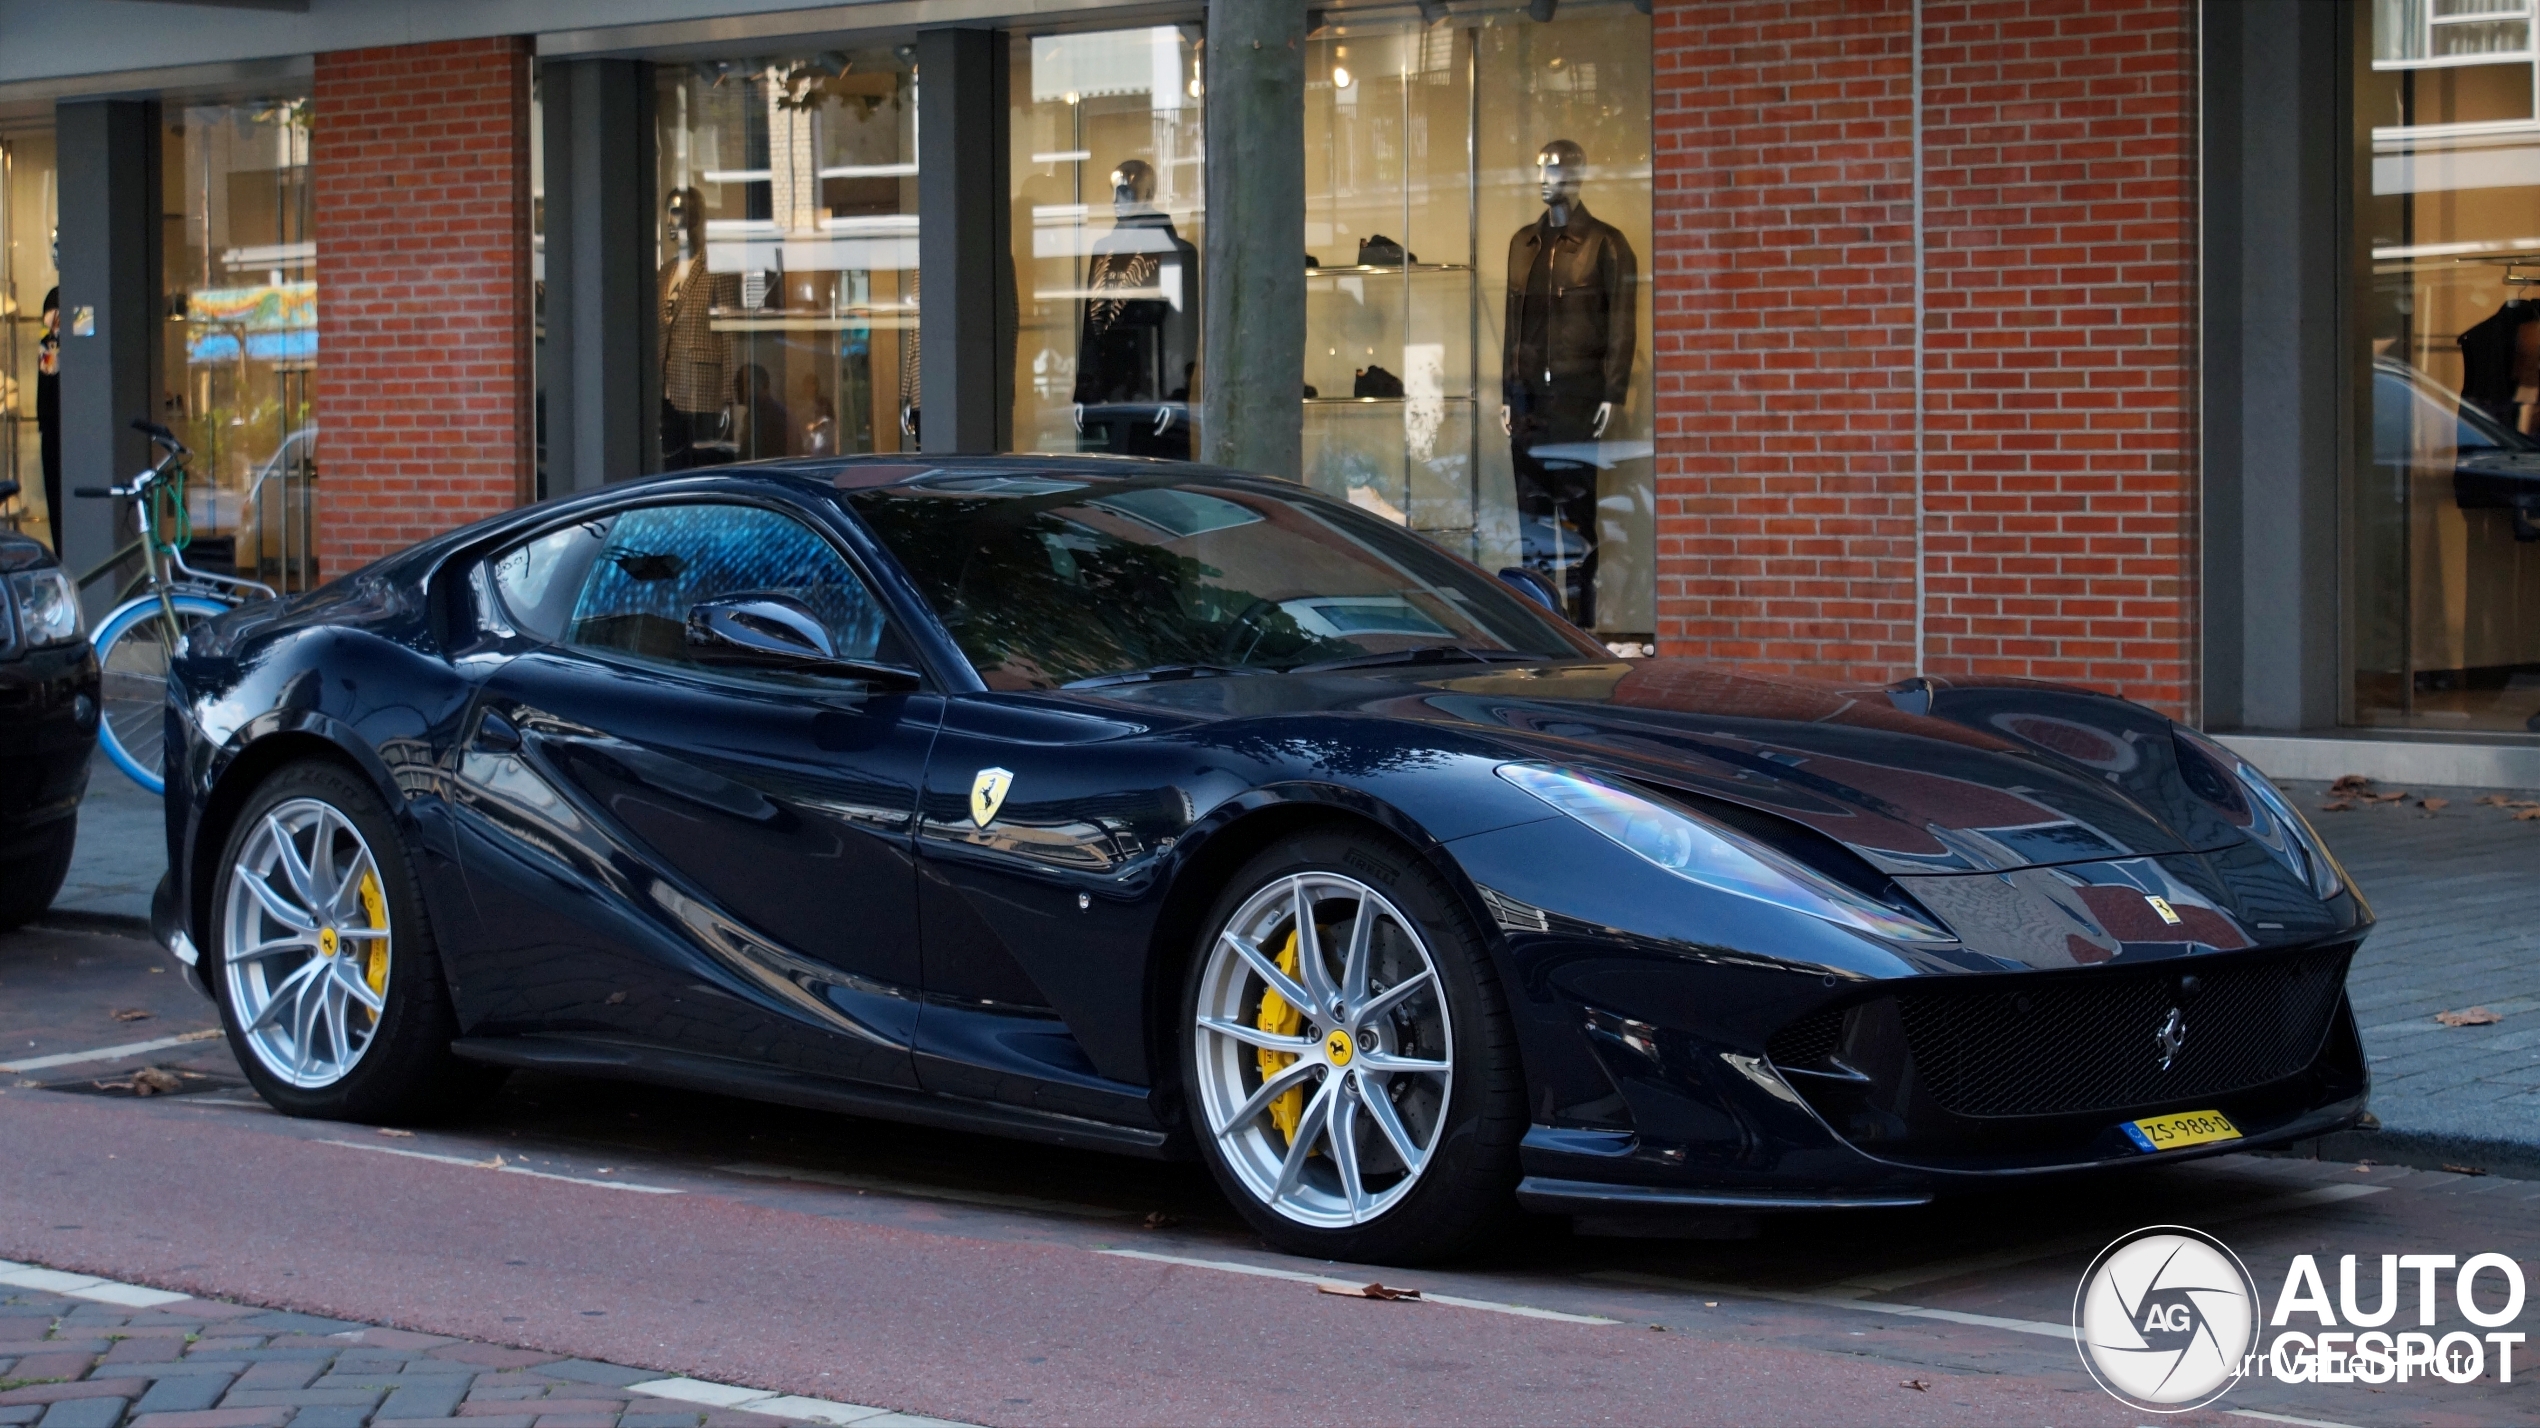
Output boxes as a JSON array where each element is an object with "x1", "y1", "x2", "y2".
[{"x1": 1499, "y1": 765, "x2": 1958, "y2": 943}]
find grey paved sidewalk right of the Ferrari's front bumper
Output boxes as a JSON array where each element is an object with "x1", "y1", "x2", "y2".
[{"x1": 2286, "y1": 783, "x2": 2540, "y2": 1174}]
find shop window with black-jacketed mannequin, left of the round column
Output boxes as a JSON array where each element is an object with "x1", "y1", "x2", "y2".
[{"x1": 1008, "y1": 25, "x2": 1204, "y2": 460}]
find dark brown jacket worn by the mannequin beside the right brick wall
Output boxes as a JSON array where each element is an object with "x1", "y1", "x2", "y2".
[{"x1": 1499, "y1": 203, "x2": 1641, "y2": 404}]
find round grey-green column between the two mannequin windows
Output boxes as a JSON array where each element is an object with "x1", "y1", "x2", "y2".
[{"x1": 1199, "y1": 0, "x2": 1306, "y2": 478}]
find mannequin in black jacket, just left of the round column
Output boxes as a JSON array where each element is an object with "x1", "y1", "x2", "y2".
[{"x1": 1074, "y1": 158, "x2": 1199, "y2": 449}]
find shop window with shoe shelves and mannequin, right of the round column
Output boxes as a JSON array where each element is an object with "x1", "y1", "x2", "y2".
[{"x1": 1306, "y1": 3, "x2": 1656, "y2": 643}]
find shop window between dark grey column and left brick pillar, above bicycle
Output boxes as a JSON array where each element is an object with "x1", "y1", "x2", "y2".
[{"x1": 160, "y1": 97, "x2": 318, "y2": 589}]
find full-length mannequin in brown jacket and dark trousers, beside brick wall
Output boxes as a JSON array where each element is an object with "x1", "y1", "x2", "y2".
[{"x1": 1499, "y1": 140, "x2": 1638, "y2": 628}]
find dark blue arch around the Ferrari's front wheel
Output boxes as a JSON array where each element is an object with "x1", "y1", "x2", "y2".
[{"x1": 1140, "y1": 785, "x2": 1499, "y2": 1156}]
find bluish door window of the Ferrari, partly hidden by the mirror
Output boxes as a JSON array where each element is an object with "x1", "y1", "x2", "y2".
[{"x1": 564, "y1": 503, "x2": 886, "y2": 666}]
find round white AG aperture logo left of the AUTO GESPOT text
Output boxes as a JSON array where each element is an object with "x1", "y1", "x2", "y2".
[{"x1": 2073, "y1": 1225, "x2": 2258, "y2": 1413}]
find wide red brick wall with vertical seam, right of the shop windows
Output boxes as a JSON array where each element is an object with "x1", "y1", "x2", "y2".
[{"x1": 1654, "y1": 0, "x2": 2195, "y2": 711}]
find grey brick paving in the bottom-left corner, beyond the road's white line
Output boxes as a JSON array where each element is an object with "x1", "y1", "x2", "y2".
[{"x1": 0, "y1": 1265, "x2": 947, "y2": 1428}]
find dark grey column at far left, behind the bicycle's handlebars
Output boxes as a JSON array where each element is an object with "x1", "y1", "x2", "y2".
[{"x1": 53, "y1": 99, "x2": 163, "y2": 623}]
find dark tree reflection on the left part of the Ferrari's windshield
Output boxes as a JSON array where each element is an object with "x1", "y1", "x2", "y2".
[{"x1": 856, "y1": 493, "x2": 1359, "y2": 689}]
